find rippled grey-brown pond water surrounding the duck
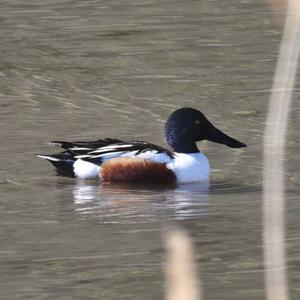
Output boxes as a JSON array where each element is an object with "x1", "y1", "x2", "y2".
[{"x1": 0, "y1": 0, "x2": 300, "y2": 300}]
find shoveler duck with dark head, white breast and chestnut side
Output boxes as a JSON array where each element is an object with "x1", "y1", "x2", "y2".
[{"x1": 37, "y1": 107, "x2": 247, "y2": 184}]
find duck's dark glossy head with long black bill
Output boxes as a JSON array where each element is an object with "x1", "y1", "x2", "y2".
[{"x1": 165, "y1": 107, "x2": 247, "y2": 153}]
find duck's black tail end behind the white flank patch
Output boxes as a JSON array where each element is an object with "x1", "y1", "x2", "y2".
[{"x1": 37, "y1": 152, "x2": 75, "y2": 177}]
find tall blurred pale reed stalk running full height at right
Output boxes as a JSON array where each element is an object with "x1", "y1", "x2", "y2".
[{"x1": 263, "y1": 0, "x2": 300, "y2": 300}]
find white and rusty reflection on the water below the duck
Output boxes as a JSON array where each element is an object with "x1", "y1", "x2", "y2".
[{"x1": 73, "y1": 181, "x2": 210, "y2": 221}]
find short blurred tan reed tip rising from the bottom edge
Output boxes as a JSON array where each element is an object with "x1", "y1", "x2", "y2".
[{"x1": 165, "y1": 230, "x2": 201, "y2": 300}]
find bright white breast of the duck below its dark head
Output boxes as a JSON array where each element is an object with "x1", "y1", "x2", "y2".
[{"x1": 167, "y1": 153, "x2": 210, "y2": 183}]
